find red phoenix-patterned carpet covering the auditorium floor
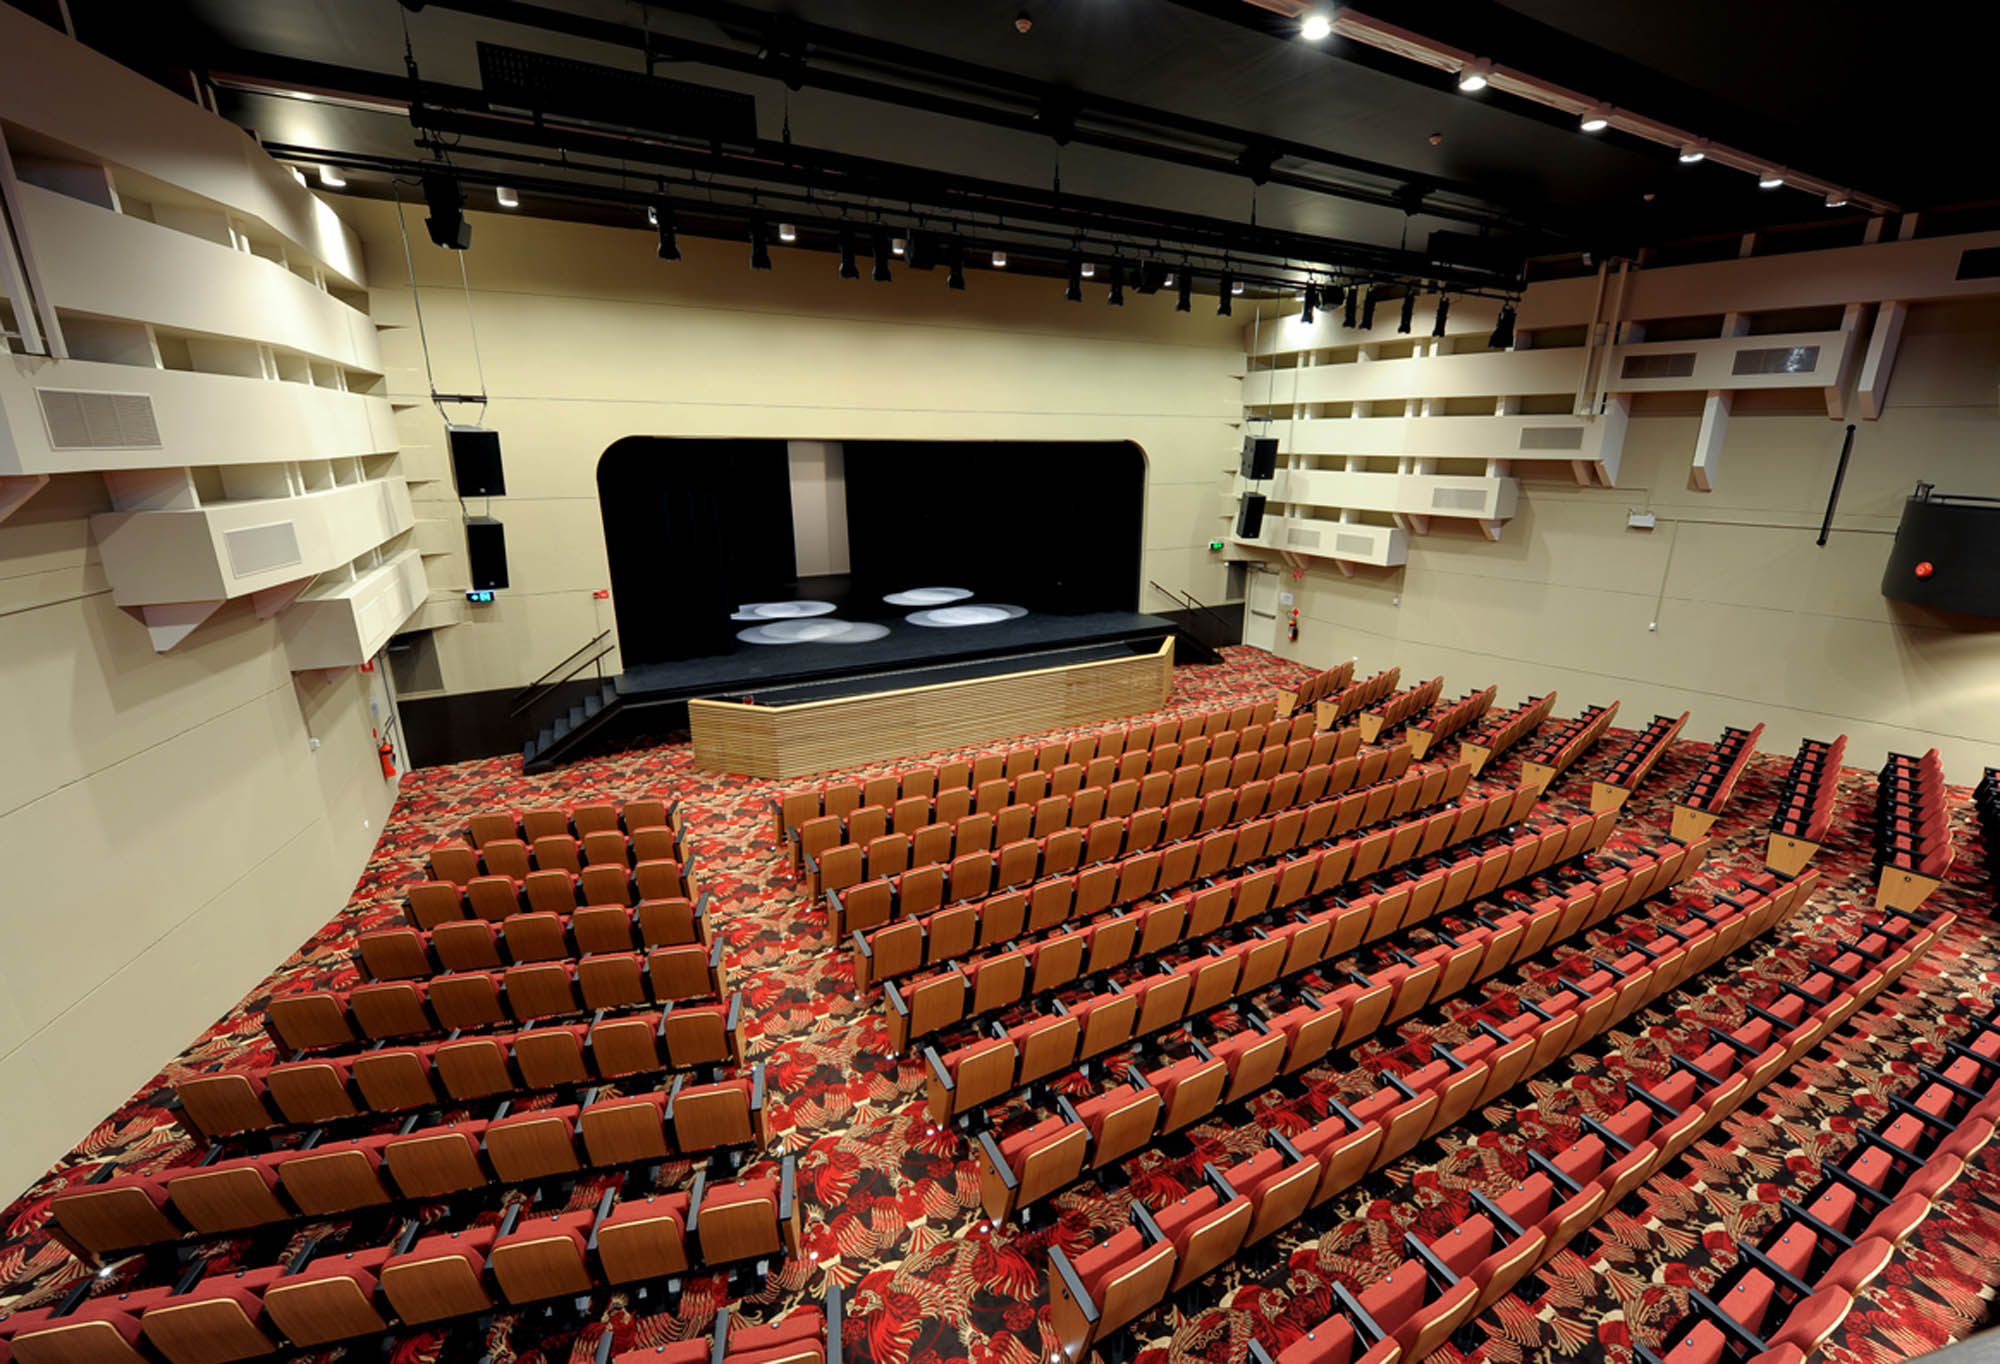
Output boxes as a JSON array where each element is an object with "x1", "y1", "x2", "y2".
[{"x1": 0, "y1": 648, "x2": 2000, "y2": 1364}]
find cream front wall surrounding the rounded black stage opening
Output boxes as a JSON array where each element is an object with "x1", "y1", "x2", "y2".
[{"x1": 340, "y1": 200, "x2": 1242, "y2": 692}]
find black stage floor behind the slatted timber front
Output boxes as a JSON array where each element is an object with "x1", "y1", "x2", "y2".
[{"x1": 616, "y1": 612, "x2": 1174, "y2": 706}]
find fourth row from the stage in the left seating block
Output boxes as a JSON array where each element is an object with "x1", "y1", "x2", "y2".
[{"x1": 356, "y1": 894, "x2": 712, "y2": 980}]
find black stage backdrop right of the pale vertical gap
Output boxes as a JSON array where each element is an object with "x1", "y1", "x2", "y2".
[{"x1": 842, "y1": 440, "x2": 1146, "y2": 614}]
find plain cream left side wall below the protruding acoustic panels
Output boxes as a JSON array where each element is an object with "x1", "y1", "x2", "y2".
[{"x1": 0, "y1": 474, "x2": 394, "y2": 1202}]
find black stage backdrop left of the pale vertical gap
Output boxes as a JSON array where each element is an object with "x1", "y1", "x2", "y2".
[{"x1": 598, "y1": 436, "x2": 798, "y2": 668}]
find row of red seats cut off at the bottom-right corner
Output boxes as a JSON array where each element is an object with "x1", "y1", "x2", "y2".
[{"x1": 1634, "y1": 960, "x2": 2000, "y2": 1364}]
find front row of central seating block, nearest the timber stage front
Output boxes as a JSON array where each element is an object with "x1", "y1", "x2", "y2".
[{"x1": 770, "y1": 702, "x2": 1296, "y2": 844}]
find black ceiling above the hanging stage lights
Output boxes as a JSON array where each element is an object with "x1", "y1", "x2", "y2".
[{"x1": 47, "y1": 0, "x2": 2000, "y2": 284}]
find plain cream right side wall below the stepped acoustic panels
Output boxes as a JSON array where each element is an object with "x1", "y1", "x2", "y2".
[{"x1": 1248, "y1": 300, "x2": 2000, "y2": 782}]
